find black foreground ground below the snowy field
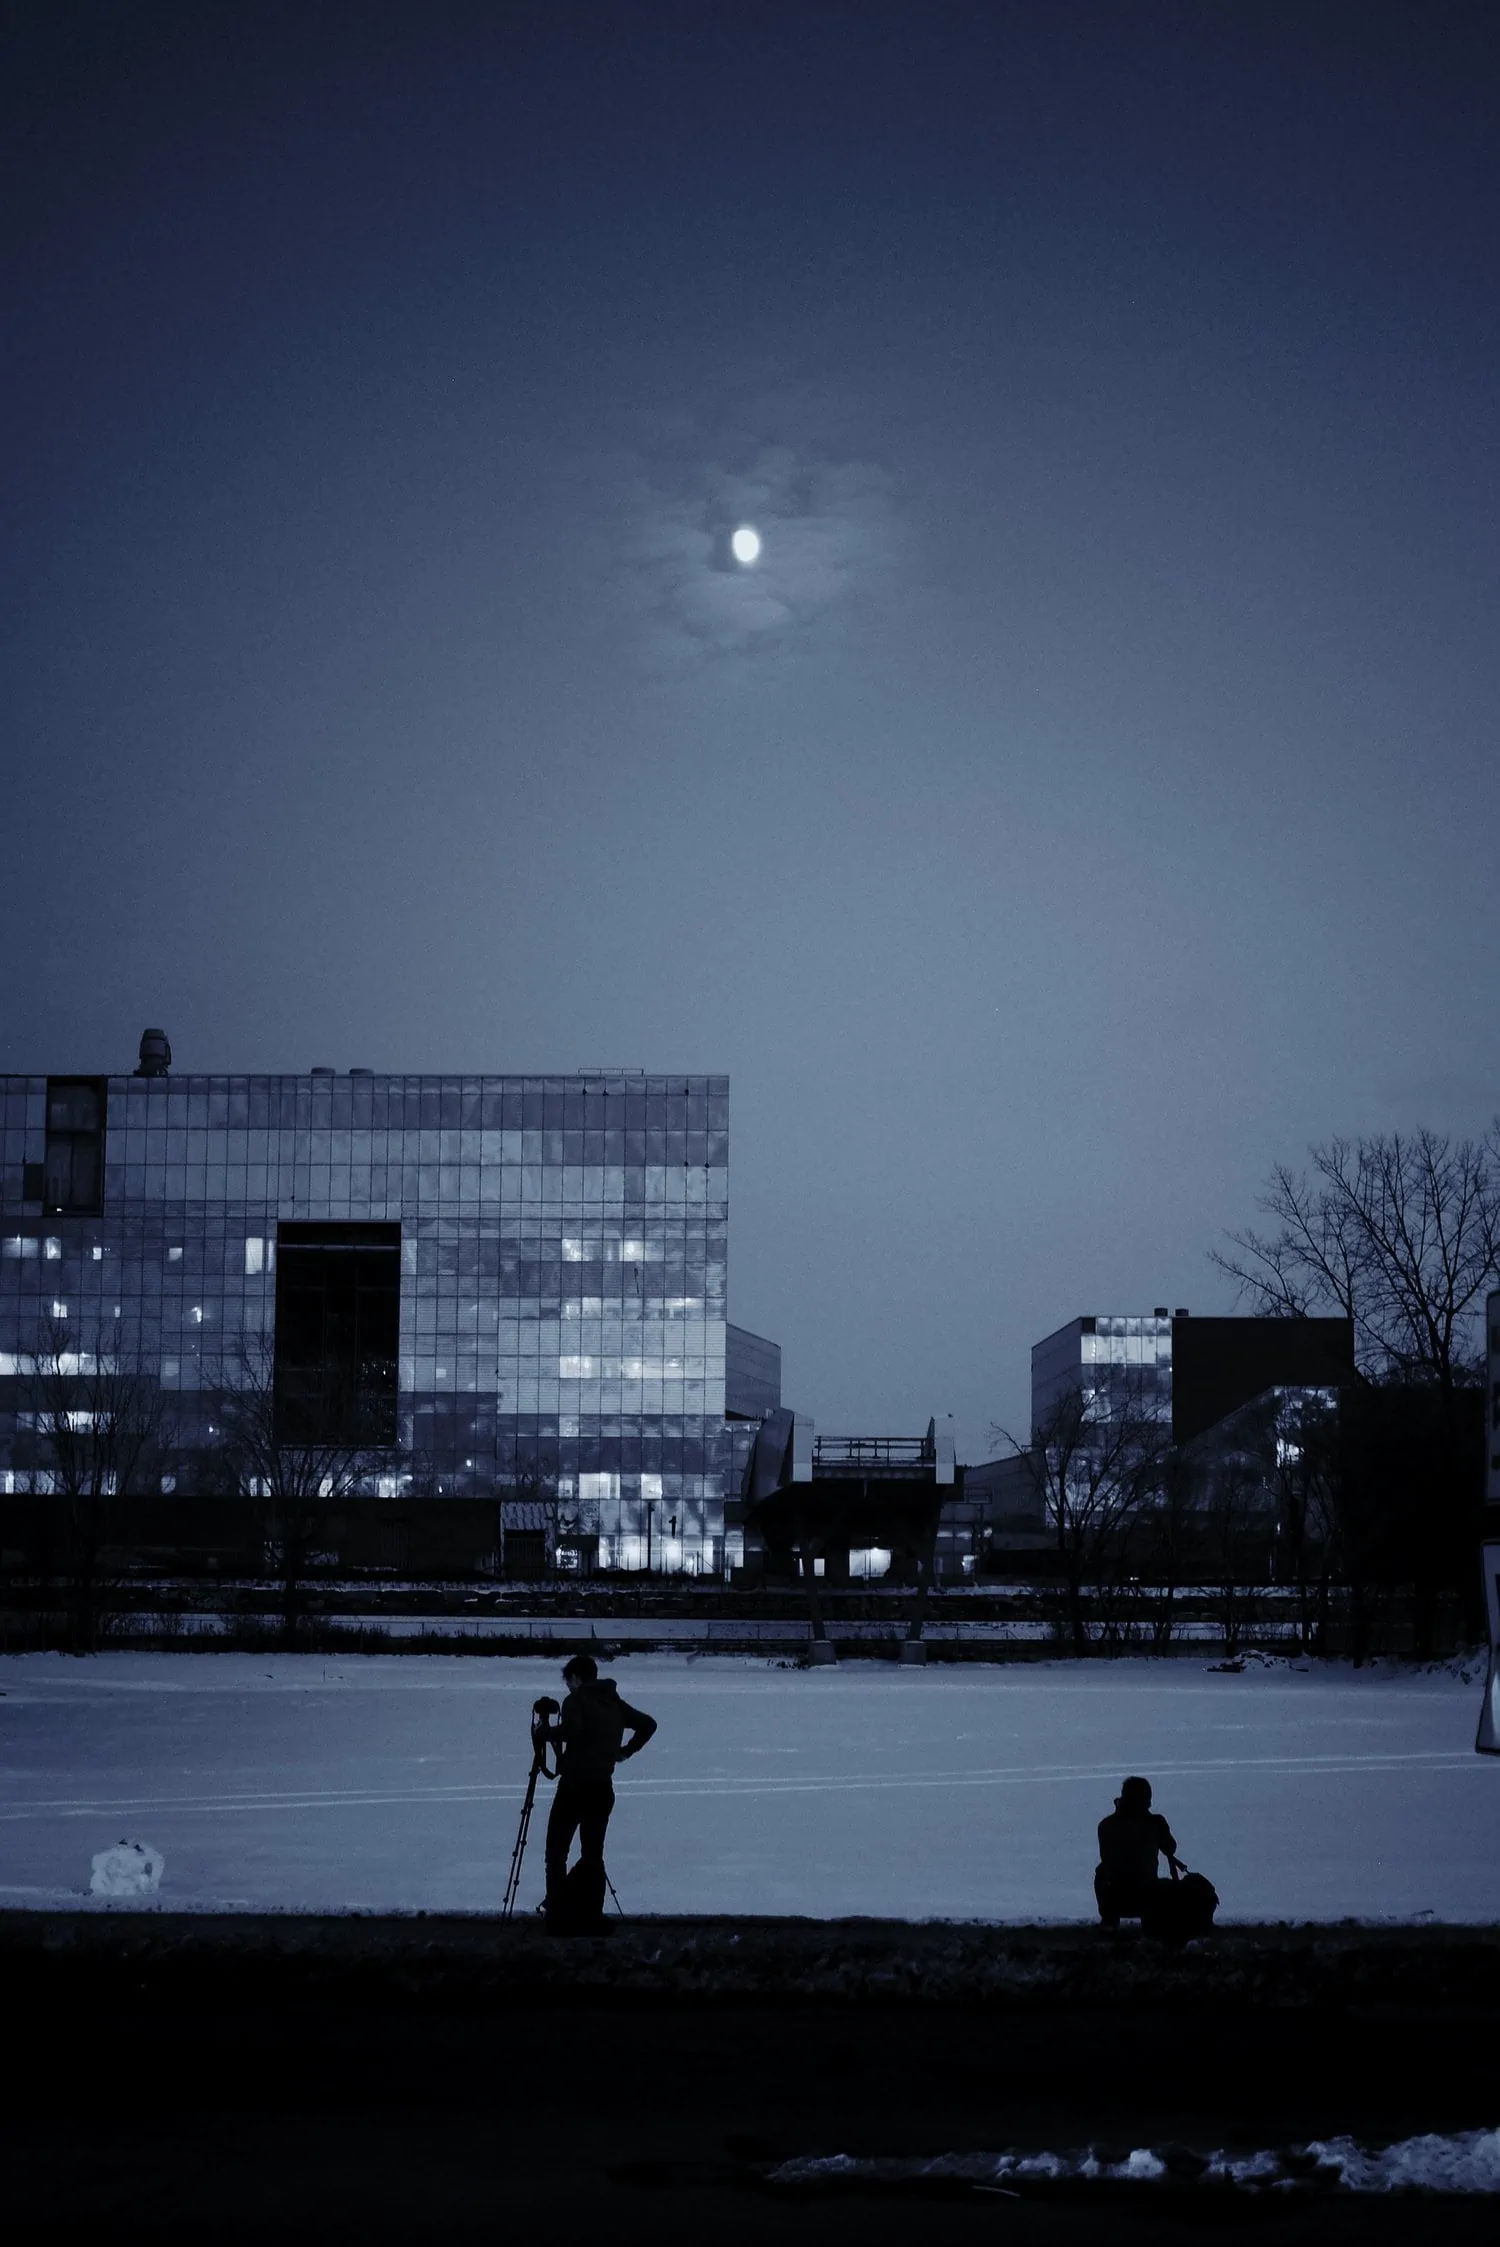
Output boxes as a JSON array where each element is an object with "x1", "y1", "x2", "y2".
[{"x1": 0, "y1": 1910, "x2": 1500, "y2": 2247}]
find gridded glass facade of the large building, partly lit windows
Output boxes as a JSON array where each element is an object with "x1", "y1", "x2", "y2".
[{"x1": 0, "y1": 1074, "x2": 739, "y2": 1568}]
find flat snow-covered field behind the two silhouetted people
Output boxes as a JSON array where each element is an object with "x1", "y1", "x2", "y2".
[{"x1": 0, "y1": 1654, "x2": 1500, "y2": 1921}]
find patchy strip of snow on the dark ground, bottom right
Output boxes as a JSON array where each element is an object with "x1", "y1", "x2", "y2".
[{"x1": 768, "y1": 2130, "x2": 1500, "y2": 2193}]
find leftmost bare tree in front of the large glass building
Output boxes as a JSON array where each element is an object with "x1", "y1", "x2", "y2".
[{"x1": 22, "y1": 1317, "x2": 173, "y2": 1654}]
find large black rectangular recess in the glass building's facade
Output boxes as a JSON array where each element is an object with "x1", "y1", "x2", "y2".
[{"x1": 274, "y1": 1222, "x2": 402, "y2": 1449}]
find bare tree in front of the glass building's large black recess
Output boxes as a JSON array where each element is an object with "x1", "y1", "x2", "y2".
[{"x1": 216, "y1": 1337, "x2": 400, "y2": 1647}]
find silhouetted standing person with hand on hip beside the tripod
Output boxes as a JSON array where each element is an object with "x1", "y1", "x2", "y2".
[{"x1": 543, "y1": 1654, "x2": 656, "y2": 1935}]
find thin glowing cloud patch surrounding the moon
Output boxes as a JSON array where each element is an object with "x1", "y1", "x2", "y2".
[{"x1": 618, "y1": 431, "x2": 894, "y2": 667}]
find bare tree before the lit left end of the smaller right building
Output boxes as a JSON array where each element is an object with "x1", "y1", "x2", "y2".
[{"x1": 995, "y1": 1384, "x2": 1172, "y2": 1654}]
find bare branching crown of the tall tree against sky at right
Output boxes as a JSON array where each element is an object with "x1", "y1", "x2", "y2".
[{"x1": 1213, "y1": 1119, "x2": 1500, "y2": 1395}]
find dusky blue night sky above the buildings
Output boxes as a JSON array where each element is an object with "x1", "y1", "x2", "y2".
[{"x1": 0, "y1": 0, "x2": 1500, "y2": 1458}]
